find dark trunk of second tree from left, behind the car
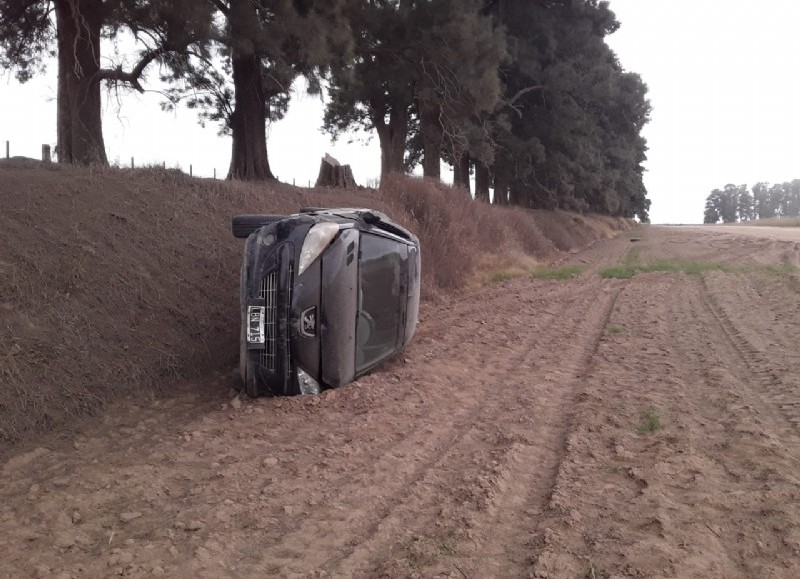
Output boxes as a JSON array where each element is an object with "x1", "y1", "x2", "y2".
[{"x1": 228, "y1": 0, "x2": 275, "y2": 181}]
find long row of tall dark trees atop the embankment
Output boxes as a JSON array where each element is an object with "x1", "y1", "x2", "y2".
[{"x1": 0, "y1": 0, "x2": 650, "y2": 219}]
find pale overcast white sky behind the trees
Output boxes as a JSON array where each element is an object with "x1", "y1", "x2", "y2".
[{"x1": 0, "y1": 0, "x2": 800, "y2": 223}]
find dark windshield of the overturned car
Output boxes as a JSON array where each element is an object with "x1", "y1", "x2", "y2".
[{"x1": 356, "y1": 233, "x2": 408, "y2": 372}]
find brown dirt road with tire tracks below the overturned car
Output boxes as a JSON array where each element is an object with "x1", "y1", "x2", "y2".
[{"x1": 0, "y1": 227, "x2": 800, "y2": 579}]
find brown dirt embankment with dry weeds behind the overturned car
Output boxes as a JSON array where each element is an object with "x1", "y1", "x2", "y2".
[{"x1": 0, "y1": 163, "x2": 627, "y2": 450}]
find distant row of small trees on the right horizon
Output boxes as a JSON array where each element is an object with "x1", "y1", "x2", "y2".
[{"x1": 703, "y1": 179, "x2": 800, "y2": 223}]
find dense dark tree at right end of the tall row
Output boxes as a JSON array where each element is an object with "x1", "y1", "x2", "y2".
[{"x1": 487, "y1": 0, "x2": 650, "y2": 221}]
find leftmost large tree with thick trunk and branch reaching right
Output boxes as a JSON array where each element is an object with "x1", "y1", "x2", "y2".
[{"x1": 0, "y1": 0, "x2": 209, "y2": 165}]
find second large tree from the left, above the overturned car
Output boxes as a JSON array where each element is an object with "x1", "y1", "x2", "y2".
[{"x1": 164, "y1": 0, "x2": 352, "y2": 180}]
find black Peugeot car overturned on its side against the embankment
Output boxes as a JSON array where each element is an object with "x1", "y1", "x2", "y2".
[{"x1": 232, "y1": 208, "x2": 420, "y2": 396}]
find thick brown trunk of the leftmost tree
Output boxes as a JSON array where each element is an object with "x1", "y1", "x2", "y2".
[{"x1": 55, "y1": 0, "x2": 108, "y2": 165}]
